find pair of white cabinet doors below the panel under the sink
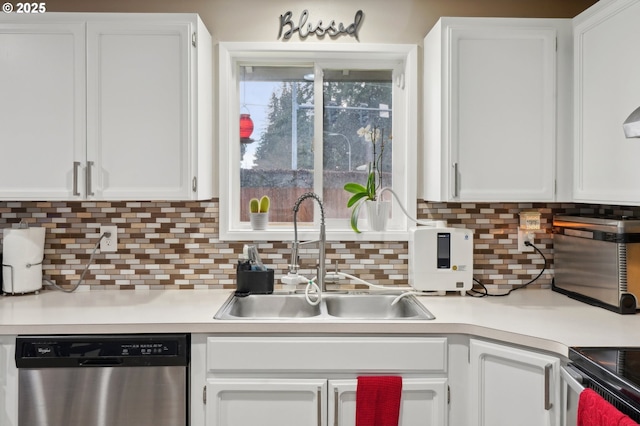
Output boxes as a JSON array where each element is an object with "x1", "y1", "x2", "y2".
[{"x1": 206, "y1": 378, "x2": 447, "y2": 426}]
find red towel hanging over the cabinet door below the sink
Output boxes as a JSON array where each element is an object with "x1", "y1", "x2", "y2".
[{"x1": 356, "y1": 376, "x2": 402, "y2": 426}]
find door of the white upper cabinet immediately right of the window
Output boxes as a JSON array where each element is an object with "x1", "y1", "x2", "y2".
[{"x1": 451, "y1": 27, "x2": 556, "y2": 201}]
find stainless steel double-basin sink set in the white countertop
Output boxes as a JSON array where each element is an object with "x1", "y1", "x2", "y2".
[{"x1": 214, "y1": 293, "x2": 435, "y2": 321}]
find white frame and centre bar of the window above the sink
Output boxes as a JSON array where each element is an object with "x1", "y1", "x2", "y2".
[{"x1": 218, "y1": 42, "x2": 418, "y2": 241}]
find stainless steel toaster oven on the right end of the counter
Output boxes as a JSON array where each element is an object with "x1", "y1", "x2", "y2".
[{"x1": 552, "y1": 215, "x2": 640, "y2": 314}]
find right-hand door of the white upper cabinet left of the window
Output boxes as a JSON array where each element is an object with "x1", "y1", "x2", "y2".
[{"x1": 87, "y1": 20, "x2": 195, "y2": 200}]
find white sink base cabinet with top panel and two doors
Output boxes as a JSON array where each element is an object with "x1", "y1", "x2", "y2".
[{"x1": 202, "y1": 336, "x2": 448, "y2": 426}]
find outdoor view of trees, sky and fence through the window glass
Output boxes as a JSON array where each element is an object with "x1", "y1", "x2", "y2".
[{"x1": 240, "y1": 65, "x2": 393, "y2": 222}]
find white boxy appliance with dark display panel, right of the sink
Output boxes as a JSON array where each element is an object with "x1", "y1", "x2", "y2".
[{"x1": 409, "y1": 226, "x2": 473, "y2": 295}]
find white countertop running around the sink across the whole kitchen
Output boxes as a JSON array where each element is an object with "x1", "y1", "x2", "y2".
[{"x1": 0, "y1": 289, "x2": 640, "y2": 356}]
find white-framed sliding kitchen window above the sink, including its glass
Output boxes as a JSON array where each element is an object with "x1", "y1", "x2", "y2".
[{"x1": 219, "y1": 43, "x2": 417, "y2": 241}]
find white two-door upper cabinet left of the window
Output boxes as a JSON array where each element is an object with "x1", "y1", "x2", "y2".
[{"x1": 0, "y1": 14, "x2": 213, "y2": 200}]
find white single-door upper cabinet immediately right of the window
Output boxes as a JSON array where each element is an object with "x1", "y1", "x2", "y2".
[{"x1": 423, "y1": 18, "x2": 570, "y2": 201}]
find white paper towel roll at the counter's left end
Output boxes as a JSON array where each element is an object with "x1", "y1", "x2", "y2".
[{"x1": 2, "y1": 228, "x2": 45, "y2": 294}]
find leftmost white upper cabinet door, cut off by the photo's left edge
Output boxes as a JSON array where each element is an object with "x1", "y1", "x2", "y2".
[{"x1": 0, "y1": 23, "x2": 86, "y2": 200}]
